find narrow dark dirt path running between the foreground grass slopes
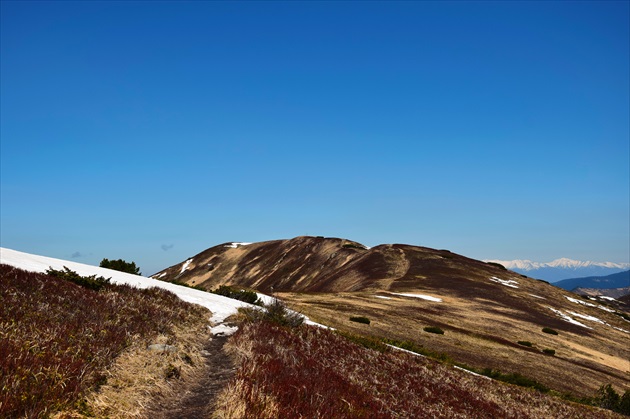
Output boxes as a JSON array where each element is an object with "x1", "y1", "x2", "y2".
[{"x1": 148, "y1": 336, "x2": 235, "y2": 419}]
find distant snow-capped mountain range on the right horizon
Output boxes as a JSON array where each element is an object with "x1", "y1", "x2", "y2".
[{"x1": 485, "y1": 258, "x2": 630, "y2": 282}]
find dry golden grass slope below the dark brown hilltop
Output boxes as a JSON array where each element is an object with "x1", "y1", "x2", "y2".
[{"x1": 279, "y1": 288, "x2": 630, "y2": 397}]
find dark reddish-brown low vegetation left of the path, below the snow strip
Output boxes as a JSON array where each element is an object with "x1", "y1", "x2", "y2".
[{"x1": 0, "y1": 265, "x2": 207, "y2": 418}]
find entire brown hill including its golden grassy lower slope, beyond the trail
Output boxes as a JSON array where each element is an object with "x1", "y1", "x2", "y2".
[{"x1": 153, "y1": 237, "x2": 630, "y2": 396}]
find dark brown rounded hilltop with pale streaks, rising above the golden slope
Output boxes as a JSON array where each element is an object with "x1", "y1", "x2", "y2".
[{"x1": 153, "y1": 236, "x2": 517, "y2": 294}]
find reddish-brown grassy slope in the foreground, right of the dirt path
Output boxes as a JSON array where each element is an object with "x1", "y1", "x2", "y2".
[{"x1": 217, "y1": 322, "x2": 617, "y2": 418}]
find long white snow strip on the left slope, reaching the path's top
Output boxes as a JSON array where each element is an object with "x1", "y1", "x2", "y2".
[{"x1": 0, "y1": 247, "x2": 254, "y2": 326}]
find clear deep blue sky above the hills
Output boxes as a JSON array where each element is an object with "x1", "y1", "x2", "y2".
[{"x1": 0, "y1": 1, "x2": 630, "y2": 274}]
